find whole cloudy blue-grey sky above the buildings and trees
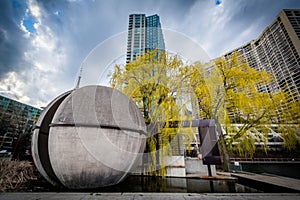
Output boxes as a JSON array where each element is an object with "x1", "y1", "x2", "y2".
[{"x1": 0, "y1": 0, "x2": 300, "y2": 107}]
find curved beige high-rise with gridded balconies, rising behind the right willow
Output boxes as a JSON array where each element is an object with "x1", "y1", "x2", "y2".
[{"x1": 224, "y1": 10, "x2": 300, "y2": 101}]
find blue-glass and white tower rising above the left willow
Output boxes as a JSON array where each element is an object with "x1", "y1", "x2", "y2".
[{"x1": 126, "y1": 14, "x2": 165, "y2": 63}]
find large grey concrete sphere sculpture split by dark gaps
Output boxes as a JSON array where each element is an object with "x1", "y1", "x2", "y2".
[{"x1": 32, "y1": 86, "x2": 146, "y2": 189}]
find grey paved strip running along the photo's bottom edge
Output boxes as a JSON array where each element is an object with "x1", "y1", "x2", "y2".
[{"x1": 0, "y1": 193, "x2": 300, "y2": 200}]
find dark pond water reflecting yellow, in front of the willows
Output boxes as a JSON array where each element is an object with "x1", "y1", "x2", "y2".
[{"x1": 89, "y1": 176, "x2": 262, "y2": 193}]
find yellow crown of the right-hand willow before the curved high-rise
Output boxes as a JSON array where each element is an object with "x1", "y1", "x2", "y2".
[{"x1": 190, "y1": 52, "x2": 299, "y2": 157}]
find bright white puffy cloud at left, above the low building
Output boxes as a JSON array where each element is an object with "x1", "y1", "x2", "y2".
[{"x1": 0, "y1": 0, "x2": 71, "y2": 106}]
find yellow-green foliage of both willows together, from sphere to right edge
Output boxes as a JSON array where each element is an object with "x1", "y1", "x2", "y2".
[{"x1": 110, "y1": 50, "x2": 300, "y2": 167}]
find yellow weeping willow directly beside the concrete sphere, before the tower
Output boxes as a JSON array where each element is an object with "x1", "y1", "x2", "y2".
[{"x1": 110, "y1": 50, "x2": 192, "y2": 175}]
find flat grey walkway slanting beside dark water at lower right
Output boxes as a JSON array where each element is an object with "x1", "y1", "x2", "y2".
[{"x1": 231, "y1": 173, "x2": 300, "y2": 192}]
